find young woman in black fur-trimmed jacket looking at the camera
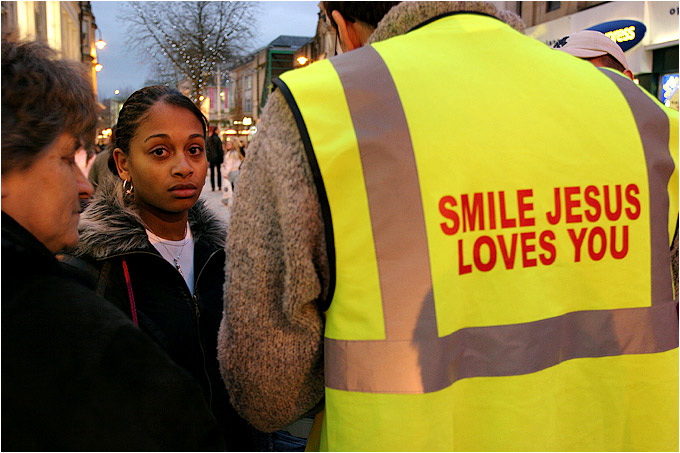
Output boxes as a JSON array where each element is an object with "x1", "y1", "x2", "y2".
[{"x1": 75, "y1": 86, "x2": 254, "y2": 451}]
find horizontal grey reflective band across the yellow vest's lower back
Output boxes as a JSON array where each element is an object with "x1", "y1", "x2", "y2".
[{"x1": 325, "y1": 303, "x2": 678, "y2": 393}]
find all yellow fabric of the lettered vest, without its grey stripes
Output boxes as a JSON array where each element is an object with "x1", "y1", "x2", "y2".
[{"x1": 282, "y1": 15, "x2": 678, "y2": 451}]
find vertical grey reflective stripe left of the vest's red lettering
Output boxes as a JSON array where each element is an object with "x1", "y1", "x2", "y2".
[{"x1": 330, "y1": 47, "x2": 437, "y2": 340}]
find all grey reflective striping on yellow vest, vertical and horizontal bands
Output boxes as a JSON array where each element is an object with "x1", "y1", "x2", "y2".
[{"x1": 325, "y1": 47, "x2": 678, "y2": 393}]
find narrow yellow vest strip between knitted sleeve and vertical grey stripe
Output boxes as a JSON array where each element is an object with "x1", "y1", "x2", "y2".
[{"x1": 281, "y1": 60, "x2": 385, "y2": 340}]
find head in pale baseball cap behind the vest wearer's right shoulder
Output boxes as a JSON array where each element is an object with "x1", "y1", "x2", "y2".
[{"x1": 553, "y1": 30, "x2": 635, "y2": 80}]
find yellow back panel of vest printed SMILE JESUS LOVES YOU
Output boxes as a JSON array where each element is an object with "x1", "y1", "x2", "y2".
[{"x1": 375, "y1": 25, "x2": 650, "y2": 336}]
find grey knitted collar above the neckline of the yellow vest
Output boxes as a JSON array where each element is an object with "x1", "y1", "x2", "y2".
[{"x1": 367, "y1": 2, "x2": 525, "y2": 44}]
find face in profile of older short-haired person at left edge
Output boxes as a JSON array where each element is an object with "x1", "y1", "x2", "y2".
[{"x1": 2, "y1": 133, "x2": 93, "y2": 253}]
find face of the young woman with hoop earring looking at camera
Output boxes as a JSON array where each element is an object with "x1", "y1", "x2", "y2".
[{"x1": 114, "y1": 101, "x2": 208, "y2": 218}]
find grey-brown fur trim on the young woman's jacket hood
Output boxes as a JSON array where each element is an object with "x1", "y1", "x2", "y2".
[{"x1": 74, "y1": 178, "x2": 227, "y2": 259}]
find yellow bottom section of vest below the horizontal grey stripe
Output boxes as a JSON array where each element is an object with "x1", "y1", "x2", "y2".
[{"x1": 320, "y1": 349, "x2": 678, "y2": 451}]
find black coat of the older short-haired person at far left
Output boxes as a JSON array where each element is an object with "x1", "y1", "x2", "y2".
[{"x1": 2, "y1": 212, "x2": 225, "y2": 451}]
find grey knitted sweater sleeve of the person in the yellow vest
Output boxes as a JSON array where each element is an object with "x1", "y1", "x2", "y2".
[{"x1": 218, "y1": 91, "x2": 329, "y2": 431}]
